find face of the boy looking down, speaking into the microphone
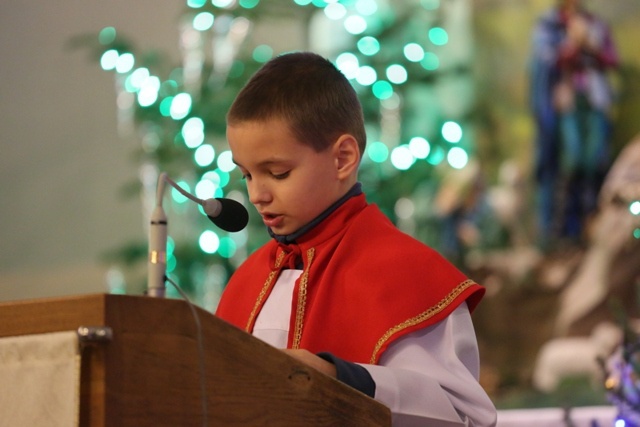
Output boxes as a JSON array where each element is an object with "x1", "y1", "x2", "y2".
[{"x1": 227, "y1": 119, "x2": 351, "y2": 235}]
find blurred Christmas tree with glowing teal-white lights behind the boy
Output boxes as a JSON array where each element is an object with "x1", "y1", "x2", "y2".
[{"x1": 78, "y1": 0, "x2": 479, "y2": 310}]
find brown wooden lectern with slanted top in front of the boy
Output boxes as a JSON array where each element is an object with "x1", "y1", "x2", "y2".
[{"x1": 0, "y1": 295, "x2": 391, "y2": 427}]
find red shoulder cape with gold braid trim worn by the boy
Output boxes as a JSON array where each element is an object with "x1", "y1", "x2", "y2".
[{"x1": 216, "y1": 195, "x2": 484, "y2": 363}]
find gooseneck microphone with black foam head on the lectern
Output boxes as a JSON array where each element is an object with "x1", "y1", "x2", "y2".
[{"x1": 147, "y1": 172, "x2": 249, "y2": 298}]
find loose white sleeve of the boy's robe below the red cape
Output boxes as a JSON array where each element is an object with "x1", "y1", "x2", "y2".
[{"x1": 361, "y1": 303, "x2": 496, "y2": 427}]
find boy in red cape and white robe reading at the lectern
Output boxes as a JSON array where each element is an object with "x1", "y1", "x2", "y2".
[{"x1": 216, "y1": 52, "x2": 496, "y2": 426}]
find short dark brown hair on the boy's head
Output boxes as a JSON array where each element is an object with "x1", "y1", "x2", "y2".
[{"x1": 227, "y1": 52, "x2": 366, "y2": 154}]
